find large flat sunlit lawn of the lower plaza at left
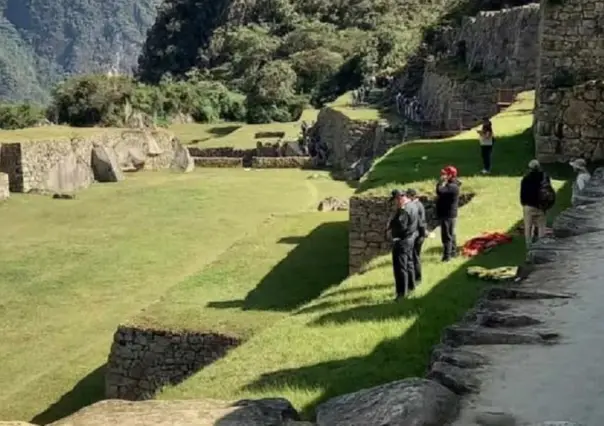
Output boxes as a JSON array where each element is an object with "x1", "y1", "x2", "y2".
[{"x1": 0, "y1": 169, "x2": 352, "y2": 420}]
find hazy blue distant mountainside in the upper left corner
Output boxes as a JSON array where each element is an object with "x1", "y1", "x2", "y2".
[{"x1": 0, "y1": 0, "x2": 161, "y2": 102}]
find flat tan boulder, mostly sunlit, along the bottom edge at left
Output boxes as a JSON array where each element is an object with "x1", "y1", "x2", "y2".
[{"x1": 52, "y1": 398, "x2": 299, "y2": 426}]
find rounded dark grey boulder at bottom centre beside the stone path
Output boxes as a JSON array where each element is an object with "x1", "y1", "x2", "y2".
[{"x1": 317, "y1": 378, "x2": 460, "y2": 426}]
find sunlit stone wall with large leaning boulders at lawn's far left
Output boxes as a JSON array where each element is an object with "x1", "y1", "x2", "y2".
[{"x1": 0, "y1": 129, "x2": 194, "y2": 198}]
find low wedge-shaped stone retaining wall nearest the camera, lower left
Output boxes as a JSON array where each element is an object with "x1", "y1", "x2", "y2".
[{"x1": 105, "y1": 326, "x2": 240, "y2": 400}]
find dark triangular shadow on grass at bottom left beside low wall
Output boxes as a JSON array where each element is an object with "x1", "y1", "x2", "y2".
[{"x1": 30, "y1": 365, "x2": 105, "y2": 425}]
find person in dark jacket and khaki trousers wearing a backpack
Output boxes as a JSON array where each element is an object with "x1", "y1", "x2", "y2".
[{"x1": 520, "y1": 160, "x2": 556, "y2": 249}]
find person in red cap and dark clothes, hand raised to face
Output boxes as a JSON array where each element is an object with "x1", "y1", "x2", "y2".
[{"x1": 436, "y1": 166, "x2": 461, "y2": 262}]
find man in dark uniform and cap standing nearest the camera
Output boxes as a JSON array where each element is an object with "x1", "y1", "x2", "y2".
[{"x1": 387, "y1": 190, "x2": 419, "y2": 300}]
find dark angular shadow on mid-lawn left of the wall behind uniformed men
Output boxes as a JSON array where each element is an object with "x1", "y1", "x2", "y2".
[{"x1": 208, "y1": 222, "x2": 348, "y2": 312}]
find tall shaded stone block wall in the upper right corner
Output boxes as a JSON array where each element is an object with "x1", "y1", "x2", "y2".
[{"x1": 534, "y1": 0, "x2": 604, "y2": 162}]
